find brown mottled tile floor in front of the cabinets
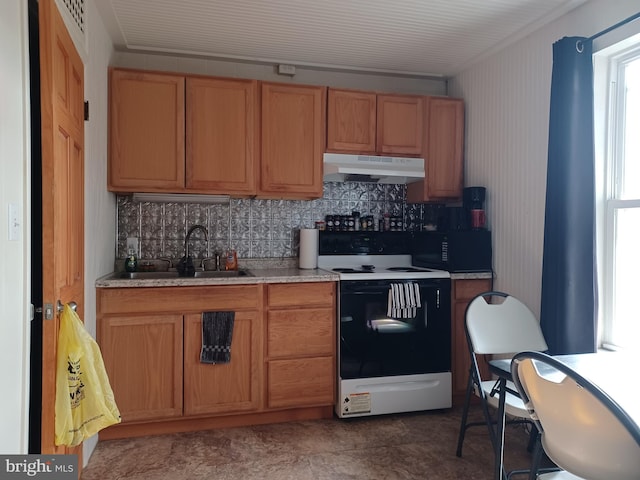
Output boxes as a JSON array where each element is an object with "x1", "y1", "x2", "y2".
[{"x1": 82, "y1": 409, "x2": 530, "y2": 480}]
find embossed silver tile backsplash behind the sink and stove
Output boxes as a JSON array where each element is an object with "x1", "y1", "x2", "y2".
[{"x1": 116, "y1": 182, "x2": 430, "y2": 259}]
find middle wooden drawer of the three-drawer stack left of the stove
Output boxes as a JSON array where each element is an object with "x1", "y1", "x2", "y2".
[{"x1": 267, "y1": 308, "x2": 335, "y2": 358}]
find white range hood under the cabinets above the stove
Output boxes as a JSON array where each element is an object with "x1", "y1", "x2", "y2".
[{"x1": 323, "y1": 153, "x2": 424, "y2": 183}]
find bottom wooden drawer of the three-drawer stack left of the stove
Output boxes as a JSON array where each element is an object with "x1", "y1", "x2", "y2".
[{"x1": 267, "y1": 357, "x2": 335, "y2": 408}]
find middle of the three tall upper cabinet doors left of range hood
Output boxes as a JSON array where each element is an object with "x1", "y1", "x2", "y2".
[{"x1": 186, "y1": 77, "x2": 258, "y2": 195}]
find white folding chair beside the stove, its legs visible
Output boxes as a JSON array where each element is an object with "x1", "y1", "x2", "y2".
[{"x1": 456, "y1": 291, "x2": 548, "y2": 464}]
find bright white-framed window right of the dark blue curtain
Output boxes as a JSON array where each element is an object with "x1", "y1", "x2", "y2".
[{"x1": 595, "y1": 42, "x2": 640, "y2": 351}]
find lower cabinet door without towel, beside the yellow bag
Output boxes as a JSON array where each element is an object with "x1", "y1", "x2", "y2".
[{"x1": 100, "y1": 314, "x2": 182, "y2": 423}]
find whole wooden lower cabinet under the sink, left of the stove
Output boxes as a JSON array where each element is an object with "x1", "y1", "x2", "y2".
[{"x1": 97, "y1": 282, "x2": 336, "y2": 438}]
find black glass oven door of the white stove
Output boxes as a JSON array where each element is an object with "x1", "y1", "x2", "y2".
[{"x1": 338, "y1": 279, "x2": 451, "y2": 379}]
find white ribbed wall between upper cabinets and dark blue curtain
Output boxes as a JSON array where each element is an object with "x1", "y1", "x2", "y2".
[{"x1": 449, "y1": 0, "x2": 640, "y2": 317}]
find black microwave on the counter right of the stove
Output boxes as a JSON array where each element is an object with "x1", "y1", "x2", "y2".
[{"x1": 411, "y1": 230, "x2": 492, "y2": 272}]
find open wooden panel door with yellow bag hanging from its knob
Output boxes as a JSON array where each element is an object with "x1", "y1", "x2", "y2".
[{"x1": 39, "y1": 0, "x2": 84, "y2": 454}]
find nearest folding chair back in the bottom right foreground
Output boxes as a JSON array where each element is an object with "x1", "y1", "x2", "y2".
[{"x1": 511, "y1": 352, "x2": 640, "y2": 480}]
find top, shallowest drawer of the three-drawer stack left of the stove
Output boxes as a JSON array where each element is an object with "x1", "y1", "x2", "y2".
[{"x1": 267, "y1": 282, "x2": 335, "y2": 307}]
